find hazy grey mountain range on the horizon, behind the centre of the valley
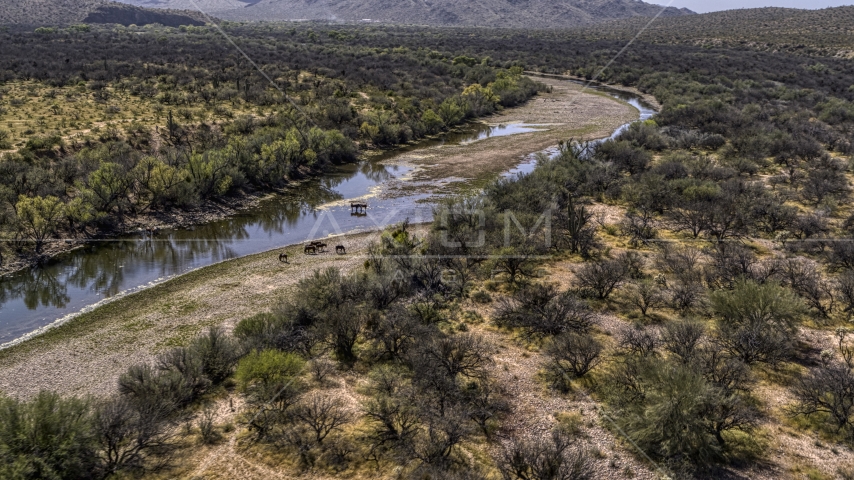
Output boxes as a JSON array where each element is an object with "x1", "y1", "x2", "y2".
[{"x1": 113, "y1": 0, "x2": 693, "y2": 28}]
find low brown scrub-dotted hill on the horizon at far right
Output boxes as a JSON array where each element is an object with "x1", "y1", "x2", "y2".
[{"x1": 590, "y1": 6, "x2": 854, "y2": 58}]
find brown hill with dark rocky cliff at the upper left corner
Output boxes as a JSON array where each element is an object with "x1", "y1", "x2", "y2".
[{"x1": 0, "y1": 0, "x2": 205, "y2": 27}]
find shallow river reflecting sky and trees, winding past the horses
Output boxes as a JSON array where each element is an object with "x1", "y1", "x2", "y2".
[{"x1": 0, "y1": 79, "x2": 655, "y2": 349}]
